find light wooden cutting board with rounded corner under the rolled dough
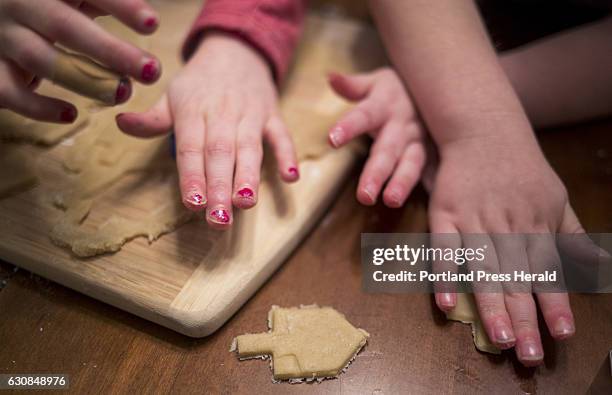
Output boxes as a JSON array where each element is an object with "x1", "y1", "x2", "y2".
[{"x1": 0, "y1": 0, "x2": 383, "y2": 337}]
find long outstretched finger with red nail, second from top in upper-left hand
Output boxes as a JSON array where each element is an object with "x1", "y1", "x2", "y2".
[{"x1": 14, "y1": 0, "x2": 161, "y2": 83}]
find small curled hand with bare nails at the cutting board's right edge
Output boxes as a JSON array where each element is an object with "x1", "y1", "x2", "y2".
[{"x1": 329, "y1": 68, "x2": 426, "y2": 208}]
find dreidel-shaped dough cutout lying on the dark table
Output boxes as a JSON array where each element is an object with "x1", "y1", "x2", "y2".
[{"x1": 234, "y1": 305, "x2": 369, "y2": 380}]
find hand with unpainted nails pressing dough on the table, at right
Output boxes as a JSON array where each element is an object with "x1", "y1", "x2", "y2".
[{"x1": 429, "y1": 134, "x2": 584, "y2": 366}]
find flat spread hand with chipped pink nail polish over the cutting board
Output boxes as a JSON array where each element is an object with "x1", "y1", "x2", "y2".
[{"x1": 117, "y1": 32, "x2": 299, "y2": 229}]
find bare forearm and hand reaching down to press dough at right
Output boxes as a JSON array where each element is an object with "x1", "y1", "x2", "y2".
[{"x1": 371, "y1": 0, "x2": 583, "y2": 366}]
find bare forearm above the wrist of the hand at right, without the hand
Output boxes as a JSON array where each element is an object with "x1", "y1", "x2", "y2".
[{"x1": 371, "y1": 0, "x2": 533, "y2": 148}]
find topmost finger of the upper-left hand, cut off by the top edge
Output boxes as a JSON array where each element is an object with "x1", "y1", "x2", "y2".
[{"x1": 90, "y1": 0, "x2": 159, "y2": 33}]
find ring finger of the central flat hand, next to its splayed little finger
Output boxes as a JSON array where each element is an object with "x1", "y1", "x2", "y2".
[{"x1": 232, "y1": 116, "x2": 263, "y2": 209}]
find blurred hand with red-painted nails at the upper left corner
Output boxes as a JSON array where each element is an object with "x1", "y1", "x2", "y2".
[{"x1": 0, "y1": 0, "x2": 161, "y2": 123}]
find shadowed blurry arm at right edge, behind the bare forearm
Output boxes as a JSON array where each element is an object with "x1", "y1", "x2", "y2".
[{"x1": 500, "y1": 18, "x2": 612, "y2": 128}]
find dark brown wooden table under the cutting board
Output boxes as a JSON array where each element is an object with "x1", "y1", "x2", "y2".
[{"x1": 0, "y1": 121, "x2": 612, "y2": 394}]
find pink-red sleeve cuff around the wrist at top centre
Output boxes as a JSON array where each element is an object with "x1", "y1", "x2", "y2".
[{"x1": 183, "y1": 0, "x2": 306, "y2": 82}]
